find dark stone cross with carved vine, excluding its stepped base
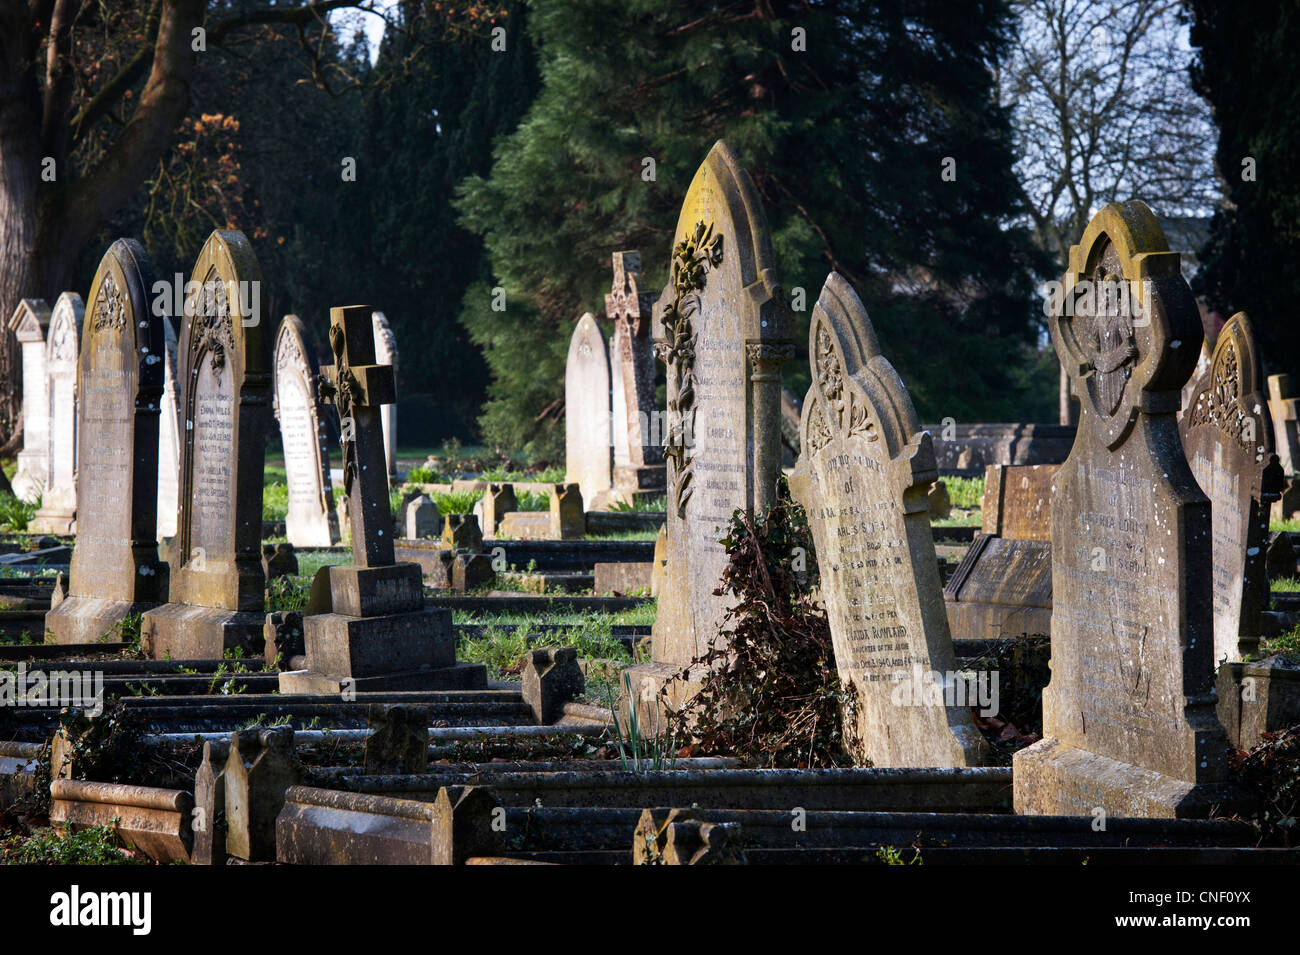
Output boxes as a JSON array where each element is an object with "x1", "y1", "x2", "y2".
[{"x1": 321, "y1": 305, "x2": 397, "y2": 567}]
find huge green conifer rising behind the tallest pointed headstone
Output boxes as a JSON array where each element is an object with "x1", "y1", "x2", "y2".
[{"x1": 459, "y1": 0, "x2": 1054, "y2": 452}]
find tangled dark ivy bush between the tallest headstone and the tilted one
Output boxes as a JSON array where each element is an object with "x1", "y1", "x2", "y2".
[{"x1": 660, "y1": 478, "x2": 857, "y2": 768}]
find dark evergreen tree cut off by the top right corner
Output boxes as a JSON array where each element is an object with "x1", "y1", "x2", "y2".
[{"x1": 1191, "y1": 0, "x2": 1300, "y2": 373}]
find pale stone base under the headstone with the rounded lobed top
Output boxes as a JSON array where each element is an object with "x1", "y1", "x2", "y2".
[{"x1": 1011, "y1": 739, "x2": 1247, "y2": 819}]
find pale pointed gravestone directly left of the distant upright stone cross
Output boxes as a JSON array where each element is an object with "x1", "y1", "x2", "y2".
[{"x1": 564, "y1": 312, "x2": 611, "y2": 509}]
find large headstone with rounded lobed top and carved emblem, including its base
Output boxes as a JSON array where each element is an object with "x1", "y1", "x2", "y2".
[{"x1": 1013, "y1": 201, "x2": 1238, "y2": 819}]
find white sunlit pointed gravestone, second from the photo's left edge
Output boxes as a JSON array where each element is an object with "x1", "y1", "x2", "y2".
[{"x1": 27, "y1": 292, "x2": 86, "y2": 534}]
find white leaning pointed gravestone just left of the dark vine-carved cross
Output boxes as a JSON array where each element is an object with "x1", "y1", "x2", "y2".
[{"x1": 276, "y1": 314, "x2": 338, "y2": 547}]
